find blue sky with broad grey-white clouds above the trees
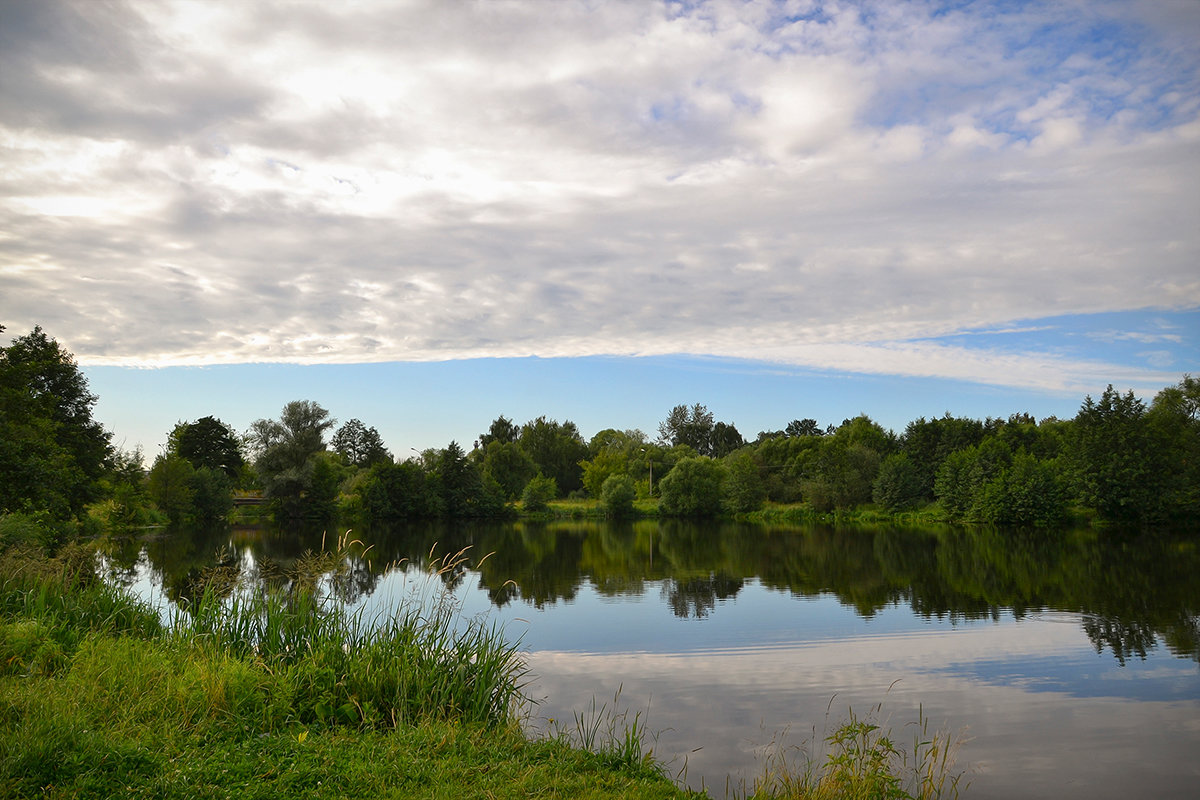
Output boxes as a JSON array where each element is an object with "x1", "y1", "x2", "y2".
[{"x1": 0, "y1": 0, "x2": 1200, "y2": 457}]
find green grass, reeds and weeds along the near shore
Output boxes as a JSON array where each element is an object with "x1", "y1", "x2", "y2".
[{"x1": 0, "y1": 524, "x2": 962, "y2": 800}]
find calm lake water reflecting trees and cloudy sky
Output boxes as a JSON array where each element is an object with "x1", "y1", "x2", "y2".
[{"x1": 109, "y1": 522, "x2": 1200, "y2": 800}]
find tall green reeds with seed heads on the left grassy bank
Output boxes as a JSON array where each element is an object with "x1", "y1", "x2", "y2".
[{"x1": 172, "y1": 537, "x2": 526, "y2": 727}]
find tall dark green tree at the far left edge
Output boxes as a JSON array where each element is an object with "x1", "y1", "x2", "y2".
[{"x1": 0, "y1": 326, "x2": 113, "y2": 517}]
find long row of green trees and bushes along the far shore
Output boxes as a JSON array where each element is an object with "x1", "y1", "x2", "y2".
[{"x1": 0, "y1": 327, "x2": 1200, "y2": 527}]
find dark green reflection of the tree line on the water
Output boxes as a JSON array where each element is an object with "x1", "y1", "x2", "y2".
[{"x1": 108, "y1": 521, "x2": 1200, "y2": 662}]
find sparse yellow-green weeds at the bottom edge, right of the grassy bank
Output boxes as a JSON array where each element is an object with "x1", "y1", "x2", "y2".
[{"x1": 746, "y1": 704, "x2": 967, "y2": 800}]
